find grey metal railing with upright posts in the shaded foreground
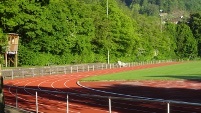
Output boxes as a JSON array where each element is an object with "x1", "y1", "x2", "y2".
[{"x1": 4, "y1": 86, "x2": 201, "y2": 113}]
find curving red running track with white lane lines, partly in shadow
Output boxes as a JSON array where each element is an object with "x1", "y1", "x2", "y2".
[{"x1": 4, "y1": 62, "x2": 201, "y2": 113}]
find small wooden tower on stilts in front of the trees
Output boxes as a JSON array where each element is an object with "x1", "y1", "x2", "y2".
[{"x1": 5, "y1": 33, "x2": 19, "y2": 67}]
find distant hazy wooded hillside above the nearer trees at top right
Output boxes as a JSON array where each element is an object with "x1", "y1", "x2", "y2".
[{"x1": 130, "y1": 0, "x2": 201, "y2": 16}]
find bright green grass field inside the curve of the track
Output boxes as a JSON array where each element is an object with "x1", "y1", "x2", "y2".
[{"x1": 81, "y1": 61, "x2": 201, "y2": 81}]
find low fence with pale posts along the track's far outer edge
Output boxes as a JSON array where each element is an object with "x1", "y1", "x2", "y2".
[{"x1": 2, "y1": 60, "x2": 172, "y2": 79}]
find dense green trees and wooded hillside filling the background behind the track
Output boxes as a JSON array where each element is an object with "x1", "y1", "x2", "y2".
[{"x1": 0, "y1": 0, "x2": 201, "y2": 66}]
